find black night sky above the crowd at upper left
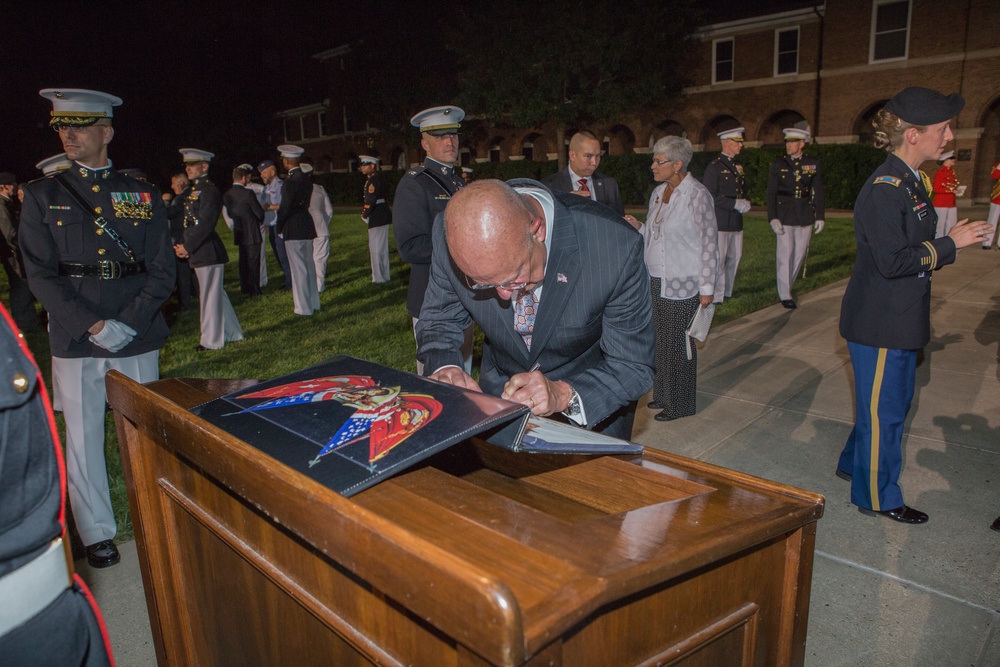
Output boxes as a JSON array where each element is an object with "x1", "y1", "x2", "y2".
[{"x1": 0, "y1": 0, "x2": 811, "y2": 187}]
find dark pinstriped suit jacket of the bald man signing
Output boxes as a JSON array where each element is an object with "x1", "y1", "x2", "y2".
[{"x1": 417, "y1": 179, "x2": 654, "y2": 438}]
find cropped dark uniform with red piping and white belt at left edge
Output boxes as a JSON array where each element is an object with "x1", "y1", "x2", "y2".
[{"x1": 0, "y1": 306, "x2": 111, "y2": 667}]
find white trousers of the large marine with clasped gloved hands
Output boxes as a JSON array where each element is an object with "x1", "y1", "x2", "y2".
[{"x1": 52, "y1": 350, "x2": 160, "y2": 546}]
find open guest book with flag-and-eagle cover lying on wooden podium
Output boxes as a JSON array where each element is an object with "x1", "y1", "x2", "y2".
[{"x1": 191, "y1": 356, "x2": 642, "y2": 496}]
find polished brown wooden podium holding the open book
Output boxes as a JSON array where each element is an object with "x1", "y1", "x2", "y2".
[{"x1": 107, "y1": 372, "x2": 823, "y2": 667}]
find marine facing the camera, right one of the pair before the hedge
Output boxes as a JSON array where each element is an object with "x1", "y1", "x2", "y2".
[{"x1": 767, "y1": 123, "x2": 825, "y2": 308}]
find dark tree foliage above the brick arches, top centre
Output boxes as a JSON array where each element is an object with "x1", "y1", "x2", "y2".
[{"x1": 452, "y1": 0, "x2": 700, "y2": 127}]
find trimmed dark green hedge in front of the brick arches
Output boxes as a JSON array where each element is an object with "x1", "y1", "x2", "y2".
[{"x1": 315, "y1": 144, "x2": 885, "y2": 209}]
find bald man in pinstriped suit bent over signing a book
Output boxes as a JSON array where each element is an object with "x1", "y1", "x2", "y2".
[{"x1": 417, "y1": 179, "x2": 654, "y2": 439}]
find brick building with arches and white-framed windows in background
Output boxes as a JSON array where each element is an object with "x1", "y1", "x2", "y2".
[{"x1": 278, "y1": 0, "x2": 1000, "y2": 201}]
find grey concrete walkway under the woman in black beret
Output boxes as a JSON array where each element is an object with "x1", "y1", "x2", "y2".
[{"x1": 77, "y1": 237, "x2": 1000, "y2": 667}]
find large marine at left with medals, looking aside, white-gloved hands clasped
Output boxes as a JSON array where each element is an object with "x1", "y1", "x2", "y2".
[{"x1": 20, "y1": 88, "x2": 174, "y2": 567}]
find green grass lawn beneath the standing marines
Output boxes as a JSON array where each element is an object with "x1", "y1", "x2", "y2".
[{"x1": 0, "y1": 211, "x2": 854, "y2": 540}]
